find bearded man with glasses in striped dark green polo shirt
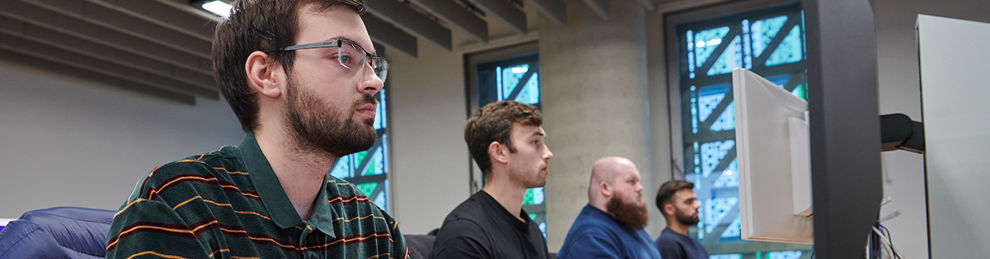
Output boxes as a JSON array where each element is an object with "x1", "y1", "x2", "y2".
[{"x1": 107, "y1": 0, "x2": 407, "y2": 258}]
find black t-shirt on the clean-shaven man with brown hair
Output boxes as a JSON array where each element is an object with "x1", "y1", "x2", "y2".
[{"x1": 432, "y1": 191, "x2": 550, "y2": 259}]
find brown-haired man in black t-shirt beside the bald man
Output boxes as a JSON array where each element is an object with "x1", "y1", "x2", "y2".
[{"x1": 432, "y1": 101, "x2": 553, "y2": 259}]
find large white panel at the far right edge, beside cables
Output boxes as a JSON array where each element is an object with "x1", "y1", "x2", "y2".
[{"x1": 920, "y1": 15, "x2": 990, "y2": 258}]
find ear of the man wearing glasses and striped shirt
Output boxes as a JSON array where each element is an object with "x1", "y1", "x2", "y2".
[{"x1": 244, "y1": 51, "x2": 285, "y2": 98}]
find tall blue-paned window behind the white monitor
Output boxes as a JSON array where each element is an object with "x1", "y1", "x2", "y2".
[{"x1": 668, "y1": 4, "x2": 811, "y2": 258}]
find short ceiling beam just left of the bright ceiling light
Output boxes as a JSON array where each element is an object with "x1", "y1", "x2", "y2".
[{"x1": 91, "y1": 0, "x2": 217, "y2": 41}]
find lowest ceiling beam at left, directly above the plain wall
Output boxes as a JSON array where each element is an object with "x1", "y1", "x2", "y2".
[{"x1": 0, "y1": 48, "x2": 196, "y2": 105}]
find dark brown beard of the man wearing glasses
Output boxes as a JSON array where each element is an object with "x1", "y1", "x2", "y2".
[{"x1": 285, "y1": 78, "x2": 378, "y2": 157}]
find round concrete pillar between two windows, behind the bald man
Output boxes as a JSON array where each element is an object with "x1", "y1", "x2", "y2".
[{"x1": 539, "y1": 1, "x2": 656, "y2": 252}]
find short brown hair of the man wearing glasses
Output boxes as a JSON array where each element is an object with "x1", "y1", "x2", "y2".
[{"x1": 212, "y1": 0, "x2": 365, "y2": 132}]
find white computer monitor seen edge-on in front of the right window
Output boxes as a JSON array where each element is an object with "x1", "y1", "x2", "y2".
[{"x1": 732, "y1": 68, "x2": 814, "y2": 244}]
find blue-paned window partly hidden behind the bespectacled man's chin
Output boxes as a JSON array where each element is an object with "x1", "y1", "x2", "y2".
[{"x1": 330, "y1": 89, "x2": 389, "y2": 212}]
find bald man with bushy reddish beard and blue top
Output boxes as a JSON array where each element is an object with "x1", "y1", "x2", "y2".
[{"x1": 557, "y1": 156, "x2": 660, "y2": 259}]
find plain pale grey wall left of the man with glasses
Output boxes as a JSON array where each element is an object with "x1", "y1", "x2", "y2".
[{"x1": 0, "y1": 62, "x2": 244, "y2": 218}]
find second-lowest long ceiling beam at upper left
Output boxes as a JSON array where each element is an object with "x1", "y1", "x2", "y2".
[{"x1": 0, "y1": 15, "x2": 216, "y2": 89}]
